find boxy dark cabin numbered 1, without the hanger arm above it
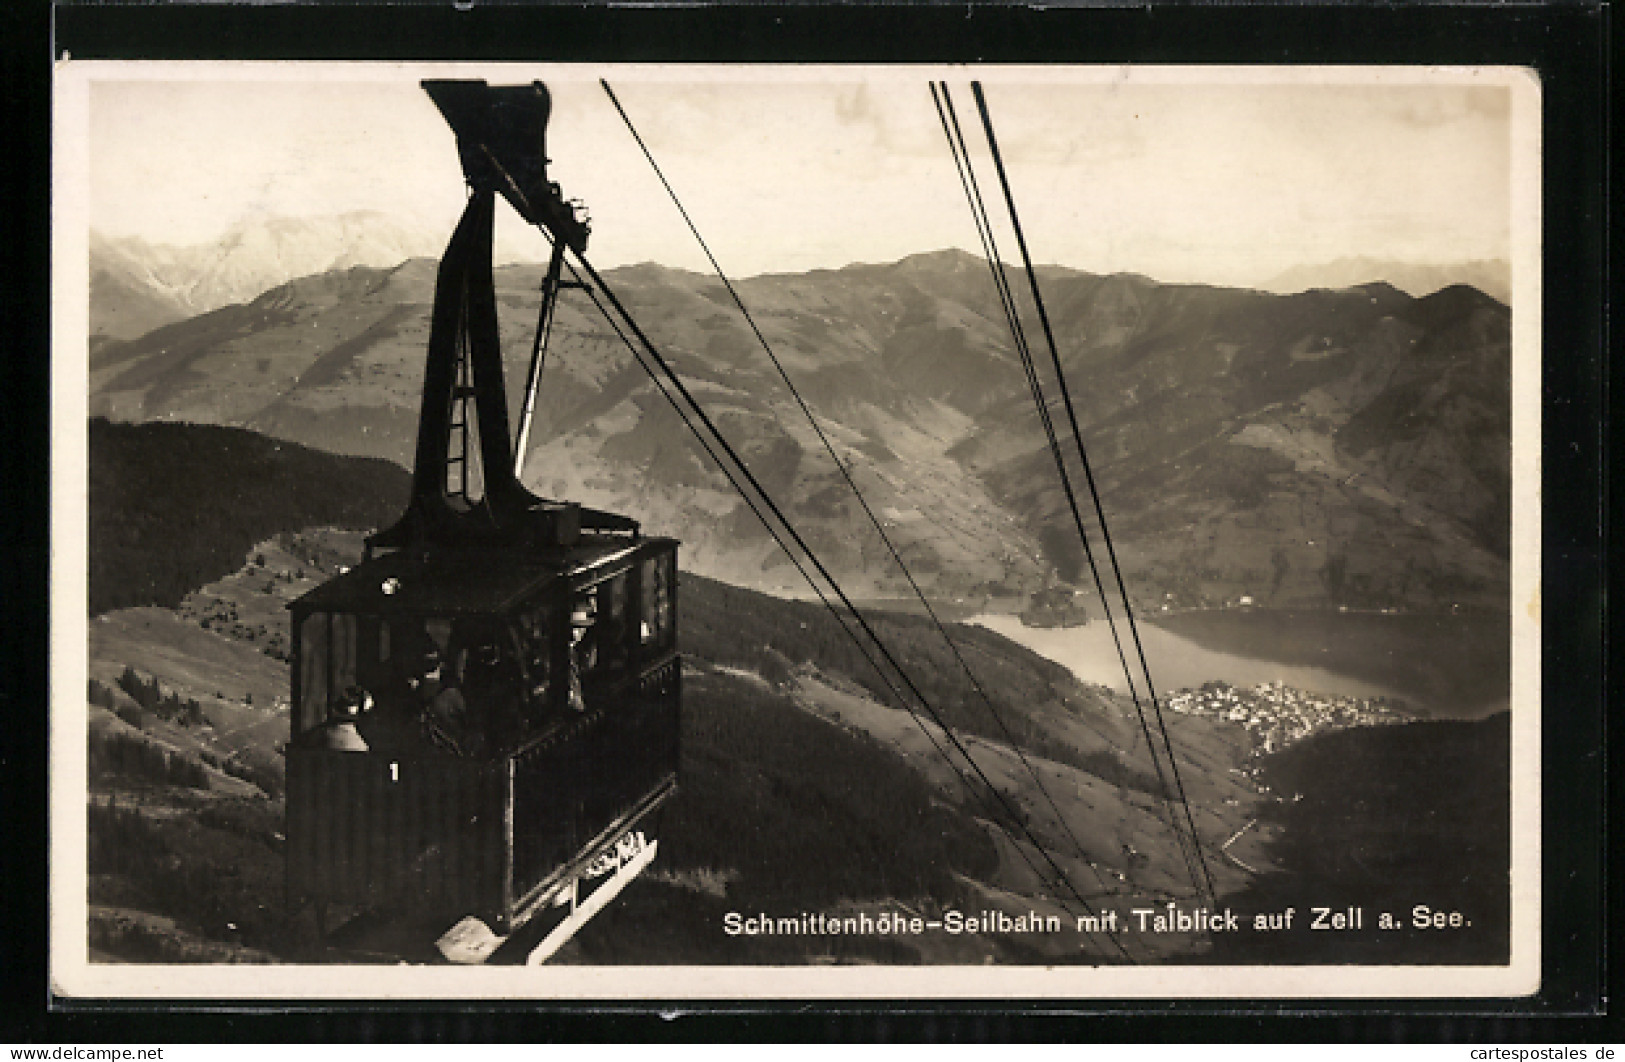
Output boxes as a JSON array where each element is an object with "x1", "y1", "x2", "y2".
[{"x1": 288, "y1": 539, "x2": 681, "y2": 927}]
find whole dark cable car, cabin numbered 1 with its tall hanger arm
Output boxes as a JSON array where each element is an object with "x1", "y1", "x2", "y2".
[{"x1": 286, "y1": 81, "x2": 681, "y2": 929}]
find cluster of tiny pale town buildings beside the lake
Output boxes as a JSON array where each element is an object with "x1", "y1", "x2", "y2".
[{"x1": 1168, "y1": 680, "x2": 1417, "y2": 753}]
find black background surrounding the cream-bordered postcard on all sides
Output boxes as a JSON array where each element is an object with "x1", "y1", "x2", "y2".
[{"x1": 0, "y1": 0, "x2": 1620, "y2": 1044}]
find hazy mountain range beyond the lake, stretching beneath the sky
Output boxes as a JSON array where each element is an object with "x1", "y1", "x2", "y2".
[{"x1": 89, "y1": 237, "x2": 1511, "y2": 611}]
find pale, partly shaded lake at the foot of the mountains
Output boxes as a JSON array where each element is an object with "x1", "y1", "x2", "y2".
[{"x1": 967, "y1": 609, "x2": 1510, "y2": 718}]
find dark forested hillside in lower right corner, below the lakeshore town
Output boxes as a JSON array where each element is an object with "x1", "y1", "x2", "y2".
[{"x1": 1214, "y1": 711, "x2": 1511, "y2": 965}]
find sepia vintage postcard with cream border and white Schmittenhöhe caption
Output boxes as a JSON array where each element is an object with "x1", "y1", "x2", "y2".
[{"x1": 50, "y1": 60, "x2": 1542, "y2": 1002}]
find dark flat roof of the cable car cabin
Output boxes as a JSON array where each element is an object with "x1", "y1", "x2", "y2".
[{"x1": 288, "y1": 537, "x2": 676, "y2": 615}]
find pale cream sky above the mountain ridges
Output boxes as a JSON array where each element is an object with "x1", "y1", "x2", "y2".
[{"x1": 88, "y1": 63, "x2": 1516, "y2": 286}]
